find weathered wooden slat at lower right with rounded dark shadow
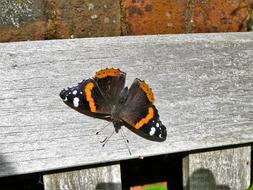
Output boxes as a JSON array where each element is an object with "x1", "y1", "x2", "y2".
[{"x1": 183, "y1": 146, "x2": 251, "y2": 190}]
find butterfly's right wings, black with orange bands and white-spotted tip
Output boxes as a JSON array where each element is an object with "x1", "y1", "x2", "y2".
[{"x1": 121, "y1": 79, "x2": 167, "y2": 141}]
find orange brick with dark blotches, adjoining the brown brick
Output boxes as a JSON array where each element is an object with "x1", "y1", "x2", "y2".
[{"x1": 124, "y1": 0, "x2": 188, "y2": 35}]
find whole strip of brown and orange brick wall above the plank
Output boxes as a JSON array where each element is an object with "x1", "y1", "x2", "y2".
[{"x1": 0, "y1": 0, "x2": 253, "y2": 42}]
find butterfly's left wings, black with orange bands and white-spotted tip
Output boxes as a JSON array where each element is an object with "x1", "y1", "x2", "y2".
[{"x1": 60, "y1": 68, "x2": 126, "y2": 118}]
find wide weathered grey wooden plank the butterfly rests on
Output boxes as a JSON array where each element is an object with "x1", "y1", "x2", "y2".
[{"x1": 0, "y1": 33, "x2": 253, "y2": 176}]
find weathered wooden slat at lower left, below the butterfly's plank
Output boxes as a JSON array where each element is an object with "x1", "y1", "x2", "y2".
[{"x1": 43, "y1": 164, "x2": 122, "y2": 190}]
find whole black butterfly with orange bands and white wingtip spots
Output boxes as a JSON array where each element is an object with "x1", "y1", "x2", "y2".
[{"x1": 60, "y1": 68, "x2": 167, "y2": 141}]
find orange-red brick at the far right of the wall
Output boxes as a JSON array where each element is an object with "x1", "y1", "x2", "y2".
[{"x1": 191, "y1": 0, "x2": 249, "y2": 32}]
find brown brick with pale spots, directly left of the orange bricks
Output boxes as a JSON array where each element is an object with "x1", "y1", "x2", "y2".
[{"x1": 46, "y1": 0, "x2": 121, "y2": 38}]
